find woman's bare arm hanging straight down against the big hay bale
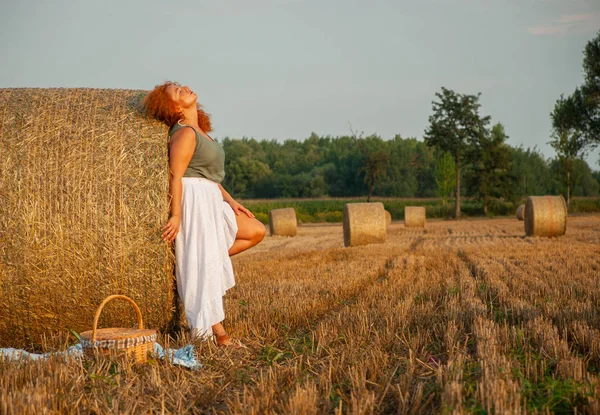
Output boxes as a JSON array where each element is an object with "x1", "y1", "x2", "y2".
[{"x1": 162, "y1": 128, "x2": 196, "y2": 242}]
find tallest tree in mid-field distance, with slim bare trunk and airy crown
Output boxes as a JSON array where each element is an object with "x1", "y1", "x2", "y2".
[{"x1": 424, "y1": 87, "x2": 490, "y2": 218}]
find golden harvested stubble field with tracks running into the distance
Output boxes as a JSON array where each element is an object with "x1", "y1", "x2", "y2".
[{"x1": 0, "y1": 215, "x2": 600, "y2": 414}]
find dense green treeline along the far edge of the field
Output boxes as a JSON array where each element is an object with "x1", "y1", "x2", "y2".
[{"x1": 222, "y1": 133, "x2": 600, "y2": 200}]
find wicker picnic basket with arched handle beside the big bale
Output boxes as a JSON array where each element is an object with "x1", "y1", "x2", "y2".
[{"x1": 80, "y1": 295, "x2": 156, "y2": 363}]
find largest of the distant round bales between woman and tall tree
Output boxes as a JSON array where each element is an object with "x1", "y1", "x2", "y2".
[{"x1": 344, "y1": 202, "x2": 386, "y2": 246}]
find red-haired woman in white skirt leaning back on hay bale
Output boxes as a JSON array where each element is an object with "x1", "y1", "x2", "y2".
[{"x1": 144, "y1": 82, "x2": 265, "y2": 346}]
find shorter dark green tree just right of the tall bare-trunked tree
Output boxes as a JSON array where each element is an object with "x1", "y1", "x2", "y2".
[{"x1": 469, "y1": 123, "x2": 510, "y2": 215}]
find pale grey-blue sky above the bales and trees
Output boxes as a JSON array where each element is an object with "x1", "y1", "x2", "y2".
[{"x1": 0, "y1": 0, "x2": 600, "y2": 170}]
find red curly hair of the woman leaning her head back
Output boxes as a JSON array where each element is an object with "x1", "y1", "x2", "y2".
[{"x1": 143, "y1": 81, "x2": 212, "y2": 133}]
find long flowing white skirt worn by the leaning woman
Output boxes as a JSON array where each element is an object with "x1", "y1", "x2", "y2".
[{"x1": 175, "y1": 177, "x2": 237, "y2": 337}]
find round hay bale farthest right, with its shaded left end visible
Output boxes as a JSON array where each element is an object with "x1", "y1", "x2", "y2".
[{"x1": 525, "y1": 196, "x2": 567, "y2": 237}]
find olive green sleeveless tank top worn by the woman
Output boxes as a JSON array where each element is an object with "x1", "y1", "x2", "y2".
[{"x1": 169, "y1": 123, "x2": 225, "y2": 183}]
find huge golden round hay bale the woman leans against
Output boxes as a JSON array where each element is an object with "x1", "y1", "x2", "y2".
[{"x1": 0, "y1": 88, "x2": 173, "y2": 347}]
